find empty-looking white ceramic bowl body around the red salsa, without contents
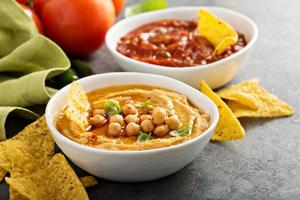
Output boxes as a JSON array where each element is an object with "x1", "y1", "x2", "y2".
[{"x1": 106, "y1": 7, "x2": 258, "y2": 88}]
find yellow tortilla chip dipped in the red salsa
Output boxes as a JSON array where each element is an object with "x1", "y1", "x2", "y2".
[{"x1": 198, "y1": 9, "x2": 238, "y2": 54}]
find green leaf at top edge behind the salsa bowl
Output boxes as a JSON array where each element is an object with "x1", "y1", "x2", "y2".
[{"x1": 125, "y1": 0, "x2": 168, "y2": 17}]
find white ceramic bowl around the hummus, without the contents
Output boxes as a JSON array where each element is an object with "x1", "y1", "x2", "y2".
[{"x1": 46, "y1": 72, "x2": 219, "y2": 182}]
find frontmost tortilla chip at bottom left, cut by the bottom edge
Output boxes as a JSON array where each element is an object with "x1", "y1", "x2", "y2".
[{"x1": 5, "y1": 154, "x2": 88, "y2": 200}]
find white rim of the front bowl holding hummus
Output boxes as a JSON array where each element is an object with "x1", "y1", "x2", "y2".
[{"x1": 45, "y1": 72, "x2": 219, "y2": 155}]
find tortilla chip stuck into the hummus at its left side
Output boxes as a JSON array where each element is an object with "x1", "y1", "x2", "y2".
[{"x1": 63, "y1": 81, "x2": 91, "y2": 132}]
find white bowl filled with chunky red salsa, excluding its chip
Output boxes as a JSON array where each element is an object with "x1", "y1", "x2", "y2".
[{"x1": 106, "y1": 7, "x2": 258, "y2": 88}]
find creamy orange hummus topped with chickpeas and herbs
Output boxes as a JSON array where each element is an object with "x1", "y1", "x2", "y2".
[{"x1": 56, "y1": 85, "x2": 210, "y2": 150}]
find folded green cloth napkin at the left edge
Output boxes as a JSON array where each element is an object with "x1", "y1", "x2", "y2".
[{"x1": 0, "y1": 0, "x2": 70, "y2": 140}]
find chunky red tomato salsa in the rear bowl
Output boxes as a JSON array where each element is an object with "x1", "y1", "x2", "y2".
[{"x1": 117, "y1": 19, "x2": 247, "y2": 67}]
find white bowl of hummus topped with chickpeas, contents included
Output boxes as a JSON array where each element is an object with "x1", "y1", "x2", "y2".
[{"x1": 46, "y1": 72, "x2": 219, "y2": 182}]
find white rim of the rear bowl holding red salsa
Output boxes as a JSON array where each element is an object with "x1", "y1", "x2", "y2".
[{"x1": 105, "y1": 6, "x2": 258, "y2": 72}]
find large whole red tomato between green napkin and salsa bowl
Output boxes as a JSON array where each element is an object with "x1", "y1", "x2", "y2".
[{"x1": 42, "y1": 0, "x2": 115, "y2": 56}]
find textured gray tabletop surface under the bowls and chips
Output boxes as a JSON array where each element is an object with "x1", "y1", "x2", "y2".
[{"x1": 0, "y1": 0, "x2": 300, "y2": 200}]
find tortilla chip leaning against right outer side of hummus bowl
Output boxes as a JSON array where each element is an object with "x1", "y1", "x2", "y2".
[{"x1": 200, "y1": 81, "x2": 245, "y2": 141}]
